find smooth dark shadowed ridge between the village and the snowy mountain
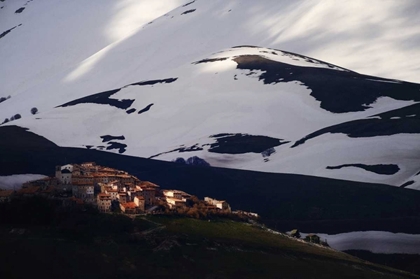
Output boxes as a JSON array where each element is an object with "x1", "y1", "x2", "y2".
[{"x1": 0, "y1": 126, "x2": 420, "y2": 233}]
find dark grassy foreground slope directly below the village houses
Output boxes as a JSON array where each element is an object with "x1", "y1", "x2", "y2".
[{"x1": 0, "y1": 215, "x2": 417, "y2": 279}]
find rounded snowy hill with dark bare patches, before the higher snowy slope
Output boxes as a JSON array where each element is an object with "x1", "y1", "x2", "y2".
[{"x1": 6, "y1": 47, "x2": 420, "y2": 187}]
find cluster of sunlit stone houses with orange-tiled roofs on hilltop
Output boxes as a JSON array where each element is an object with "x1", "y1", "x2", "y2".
[{"x1": 0, "y1": 162, "x2": 258, "y2": 218}]
